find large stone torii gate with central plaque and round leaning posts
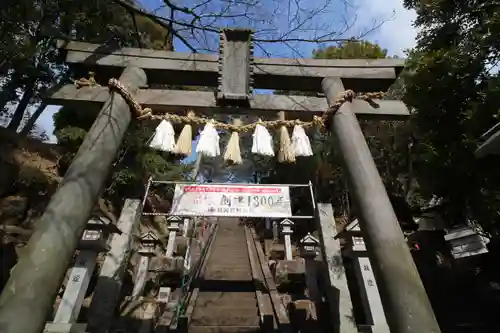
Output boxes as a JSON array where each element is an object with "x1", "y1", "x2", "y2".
[{"x1": 0, "y1": 29, "x2": 440, "y2": 333}]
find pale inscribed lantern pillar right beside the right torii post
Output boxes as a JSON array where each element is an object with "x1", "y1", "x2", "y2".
[{"x1": 346, "y1": 220, "x2": 390, "y2": 333}]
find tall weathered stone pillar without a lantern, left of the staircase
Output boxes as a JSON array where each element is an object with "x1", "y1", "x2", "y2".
[{"x1": 88, "y1": 199, "x2": 142, "y2": 333}]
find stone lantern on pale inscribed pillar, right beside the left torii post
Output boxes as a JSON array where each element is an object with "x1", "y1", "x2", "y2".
[{"x1": 45, "y1": 218, "x2": 114, "y2": 333}]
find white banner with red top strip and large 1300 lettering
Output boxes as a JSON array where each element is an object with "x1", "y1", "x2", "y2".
[{"x1": 170, "y1": 184, "x2": 292, "y2": 218}]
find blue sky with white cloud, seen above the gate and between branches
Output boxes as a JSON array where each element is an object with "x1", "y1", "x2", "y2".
[{"x1": 37, "y1": 0, "x2": 416, "y2": 147}]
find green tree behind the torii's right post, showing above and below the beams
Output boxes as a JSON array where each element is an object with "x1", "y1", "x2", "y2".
[{"x1": 266, "y1": 41, "x2": 413, "y2": 220}]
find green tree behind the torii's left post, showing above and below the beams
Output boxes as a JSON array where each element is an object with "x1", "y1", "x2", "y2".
[{"x1": 44, "y1": 2, "x2": 190, "y2": 204}]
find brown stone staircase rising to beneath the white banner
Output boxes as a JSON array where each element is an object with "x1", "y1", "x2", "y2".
[{"x1": 189, "y1": 218, "x2": 260, "y2": 333}]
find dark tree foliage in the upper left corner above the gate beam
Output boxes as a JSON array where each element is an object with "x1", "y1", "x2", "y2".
[{"x1": 0, "y1": 0, "x2": 171, "y2": 133}]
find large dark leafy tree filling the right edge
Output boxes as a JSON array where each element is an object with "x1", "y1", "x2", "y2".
[{"x1": 404, "y1": 0, "x2": 500, "y2": 225}]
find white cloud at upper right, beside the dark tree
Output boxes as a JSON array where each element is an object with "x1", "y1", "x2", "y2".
[{"x1": 355, "y1": 0, "x2": 417, "y2": 56}]
